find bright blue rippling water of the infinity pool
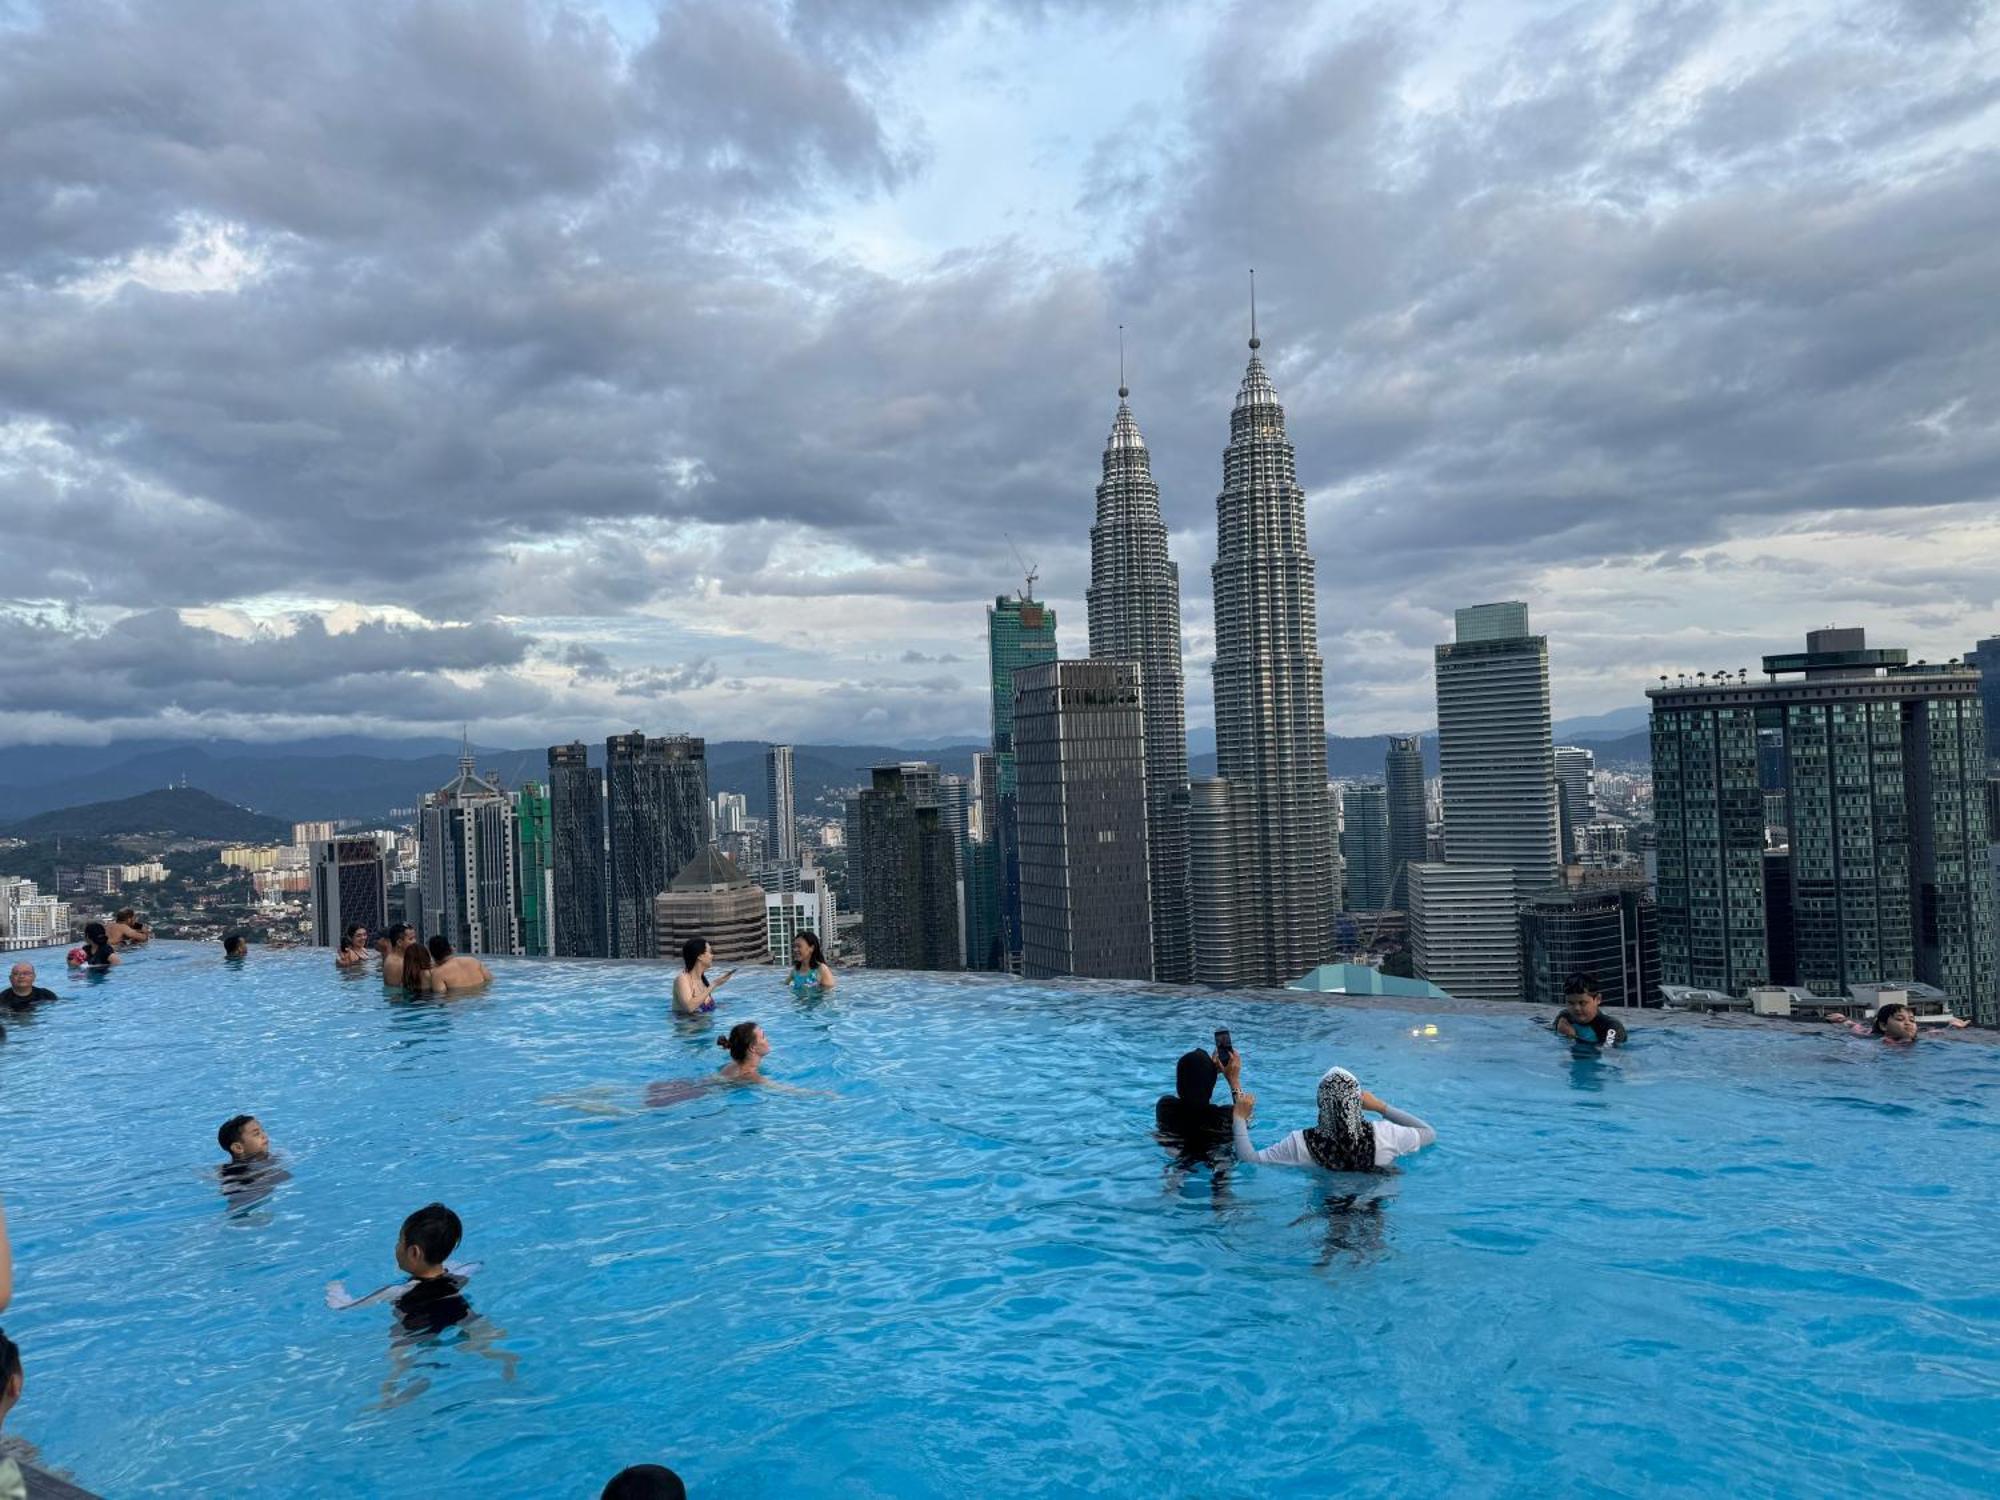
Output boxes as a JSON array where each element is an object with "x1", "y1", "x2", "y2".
[{"x1": 0, "y1": 944, "x2": 2000, "y2": 1500}]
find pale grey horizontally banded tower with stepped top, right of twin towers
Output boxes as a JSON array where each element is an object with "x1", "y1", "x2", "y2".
[{"x1": 1436, "y1": 602, "x2": 1560, "y2": 900}]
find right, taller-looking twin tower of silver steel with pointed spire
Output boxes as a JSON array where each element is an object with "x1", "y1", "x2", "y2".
[{"x1": 1190, "y1": 324, "x2": 1334, "y2": 984}]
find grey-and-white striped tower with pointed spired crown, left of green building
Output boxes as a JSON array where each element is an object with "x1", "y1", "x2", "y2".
[{"x1": 414, "y1": 748, "x2": 522, "y2": 954}]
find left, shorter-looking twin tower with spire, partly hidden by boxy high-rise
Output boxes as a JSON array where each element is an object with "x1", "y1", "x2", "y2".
[{"x1": 1084, "y1": 384, "x2": 1194, "y2": 984}]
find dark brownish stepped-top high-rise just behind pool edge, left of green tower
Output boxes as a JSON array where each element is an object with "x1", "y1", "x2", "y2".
[{"x1": 856, "y1": 764, "x2": 964, "y2": 968}]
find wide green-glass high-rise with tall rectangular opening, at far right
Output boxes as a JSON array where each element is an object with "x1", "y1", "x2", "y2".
[{"x1": 1646, "y1": 630, "x2": 2000, "y2": 1026}]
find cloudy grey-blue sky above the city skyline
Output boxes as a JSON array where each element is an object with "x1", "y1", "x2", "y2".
[{"x1": 0, "y1": 0, "x2": 2000, "y2": 744}]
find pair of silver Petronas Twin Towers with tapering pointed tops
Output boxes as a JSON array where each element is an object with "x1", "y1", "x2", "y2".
[{"x1": 1088, "y1": 330, "x2": 1334, "y2": 984}]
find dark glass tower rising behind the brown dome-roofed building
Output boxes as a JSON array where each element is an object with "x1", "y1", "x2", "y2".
[{"x1": 604, "y1": 730, "x2": 712, "y2": 958}]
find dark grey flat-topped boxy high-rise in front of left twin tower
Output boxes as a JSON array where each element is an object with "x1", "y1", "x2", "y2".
[{"x1": 1014, "y1": 660, "x2": 1154, "y2": 980}]
